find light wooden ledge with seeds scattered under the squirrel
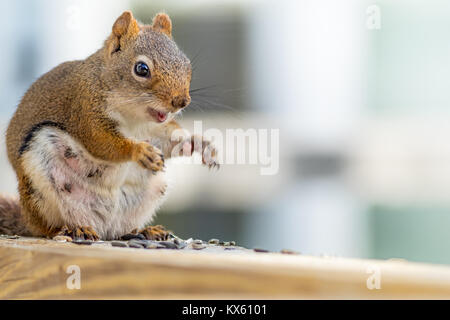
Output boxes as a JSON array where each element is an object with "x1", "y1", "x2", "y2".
[{"x1": 0, "y1": 238, "x2": 450, "y2": 299}]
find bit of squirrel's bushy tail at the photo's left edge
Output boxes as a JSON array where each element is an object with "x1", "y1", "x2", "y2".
[{"x1": 0, "y1": 194, "x2": 30, "y2": 236}]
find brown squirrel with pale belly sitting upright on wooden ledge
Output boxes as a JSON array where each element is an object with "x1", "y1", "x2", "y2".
[{"x1": 0, "y1": 11, "x2": 218, "y2": 241}]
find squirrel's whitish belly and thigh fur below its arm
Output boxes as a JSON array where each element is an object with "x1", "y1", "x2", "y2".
[{"x1": 22, "y1": 128, "x2": 167, "y2": 239}]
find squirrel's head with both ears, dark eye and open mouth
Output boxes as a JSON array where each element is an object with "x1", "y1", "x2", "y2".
[{"x1": 102, "y1": 11, "x2": 192, "y2": 123}]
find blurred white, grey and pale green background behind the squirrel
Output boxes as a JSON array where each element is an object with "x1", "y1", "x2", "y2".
[{"x1": 0, "y1": 0, "x2": 450, "y2": 264}]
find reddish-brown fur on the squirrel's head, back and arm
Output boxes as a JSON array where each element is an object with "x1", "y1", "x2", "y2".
[{"x1": 0, "y1": 11, "x2": 195, "y2": 236}]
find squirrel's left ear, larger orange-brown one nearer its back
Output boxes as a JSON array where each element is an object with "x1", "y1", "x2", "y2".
[{"x1": 107, "y1": 11, "x2": 139, "y2": 54}]
